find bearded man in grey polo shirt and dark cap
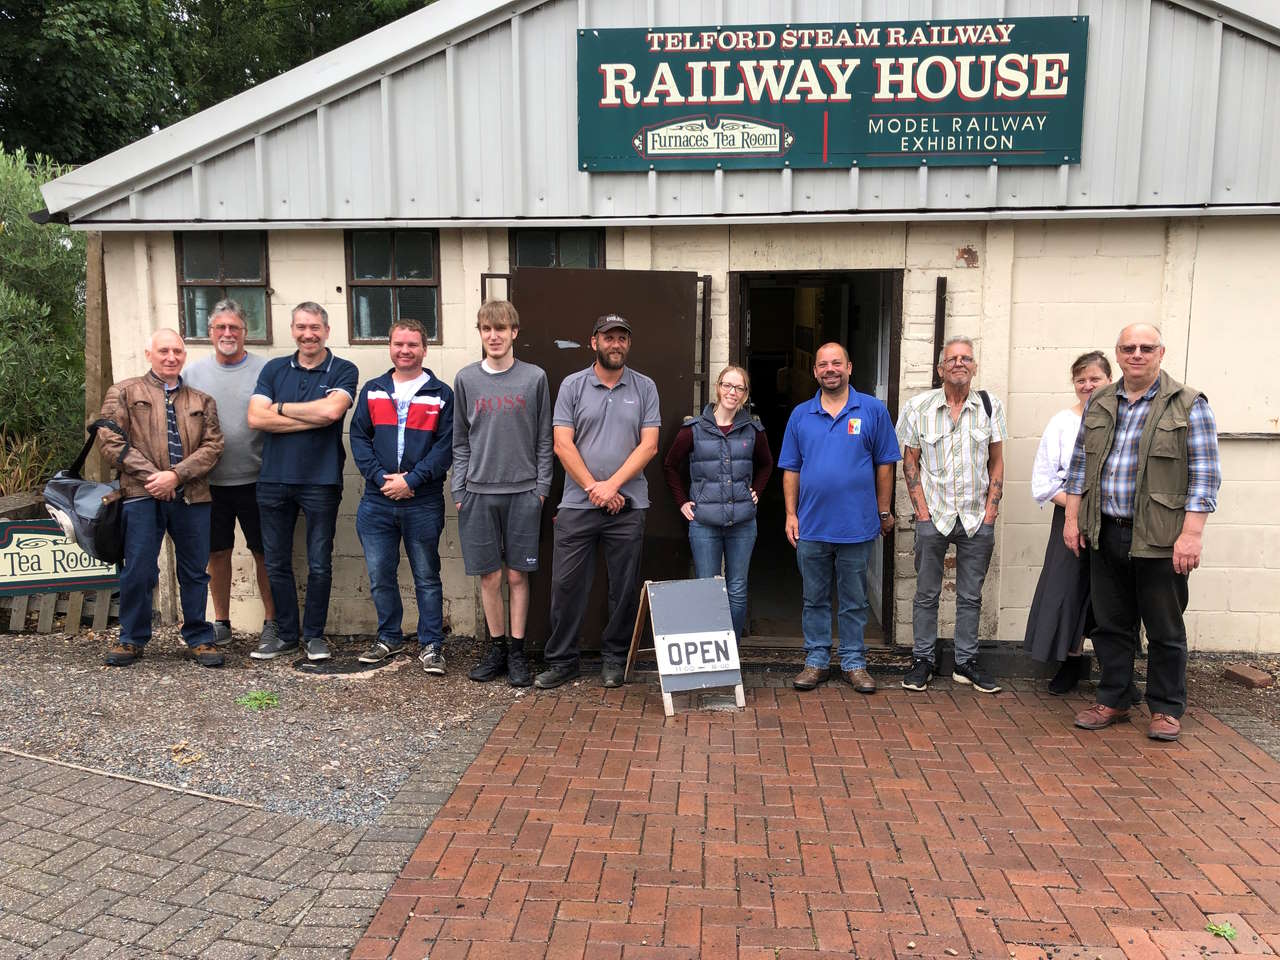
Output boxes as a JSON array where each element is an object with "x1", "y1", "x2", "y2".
[{"x1": 534, "y1": 314, "x2": 662, "y2": 689}]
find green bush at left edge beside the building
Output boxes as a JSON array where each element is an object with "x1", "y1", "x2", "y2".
[{"x1": 0, "y1": 145, "x2": 84, "y2": 489}]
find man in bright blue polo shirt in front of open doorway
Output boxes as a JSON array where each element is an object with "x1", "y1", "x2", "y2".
[{"x1": 778, "y1": 343, "x2": 902, "y2": 694}]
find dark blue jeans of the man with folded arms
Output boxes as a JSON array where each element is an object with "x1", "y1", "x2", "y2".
[{"x1": 257, "y1": 483, "x2": 342, "y2": 644}]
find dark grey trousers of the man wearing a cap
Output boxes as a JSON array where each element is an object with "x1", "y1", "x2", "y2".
[{"x1": 543, "y1": 509, "x2": 645, "y2": 664}]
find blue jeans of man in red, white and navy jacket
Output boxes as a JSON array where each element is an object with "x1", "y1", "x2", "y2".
[{"x1": 356, "y1": 494, "x2": 444, "y2": 650}]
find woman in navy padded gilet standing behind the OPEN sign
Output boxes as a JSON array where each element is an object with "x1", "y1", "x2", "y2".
[{"x1": 663, "y1": 366, "x2": 773, "y2": 640}]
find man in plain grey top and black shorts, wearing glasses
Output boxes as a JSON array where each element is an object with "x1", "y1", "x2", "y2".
[{"x1": 187, "y1": 300, "x2": 276, "y2": 644}]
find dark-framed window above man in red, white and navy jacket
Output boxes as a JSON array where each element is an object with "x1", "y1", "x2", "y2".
[{"x1": 347, "y1": 230, "x2": 440, "y2": 343}]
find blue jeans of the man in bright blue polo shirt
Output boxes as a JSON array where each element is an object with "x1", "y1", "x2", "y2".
[{"x1": 796, "y1": 540, "x2": 877, "y2": 669}]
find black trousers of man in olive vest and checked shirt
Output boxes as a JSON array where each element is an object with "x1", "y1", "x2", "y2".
[{"x1": 1089, "y1": 517, "x2": 1187, "y2": 717}]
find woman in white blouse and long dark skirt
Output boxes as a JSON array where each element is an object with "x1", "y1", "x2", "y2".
[{"x1": 1023, "y1": 351, "x2": 1111, "y2": 695}]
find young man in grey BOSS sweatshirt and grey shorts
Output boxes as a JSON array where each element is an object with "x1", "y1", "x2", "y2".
[{"x1": 452, "y1": 300, "x2": 552, "y2": 686}]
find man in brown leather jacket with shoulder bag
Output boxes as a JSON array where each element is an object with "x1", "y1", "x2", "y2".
[{"x1": 99, "y1": 330, "x2": 223, "y2": 667}]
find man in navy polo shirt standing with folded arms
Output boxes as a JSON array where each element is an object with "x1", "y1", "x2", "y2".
[{"x1": 248, "y1": 301, "x2": 360, "y2": 660}]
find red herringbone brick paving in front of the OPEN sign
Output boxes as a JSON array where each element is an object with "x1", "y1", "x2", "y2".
[{"x1": 355, "y1": 682, "x2": 1280, "y2": 960}]
